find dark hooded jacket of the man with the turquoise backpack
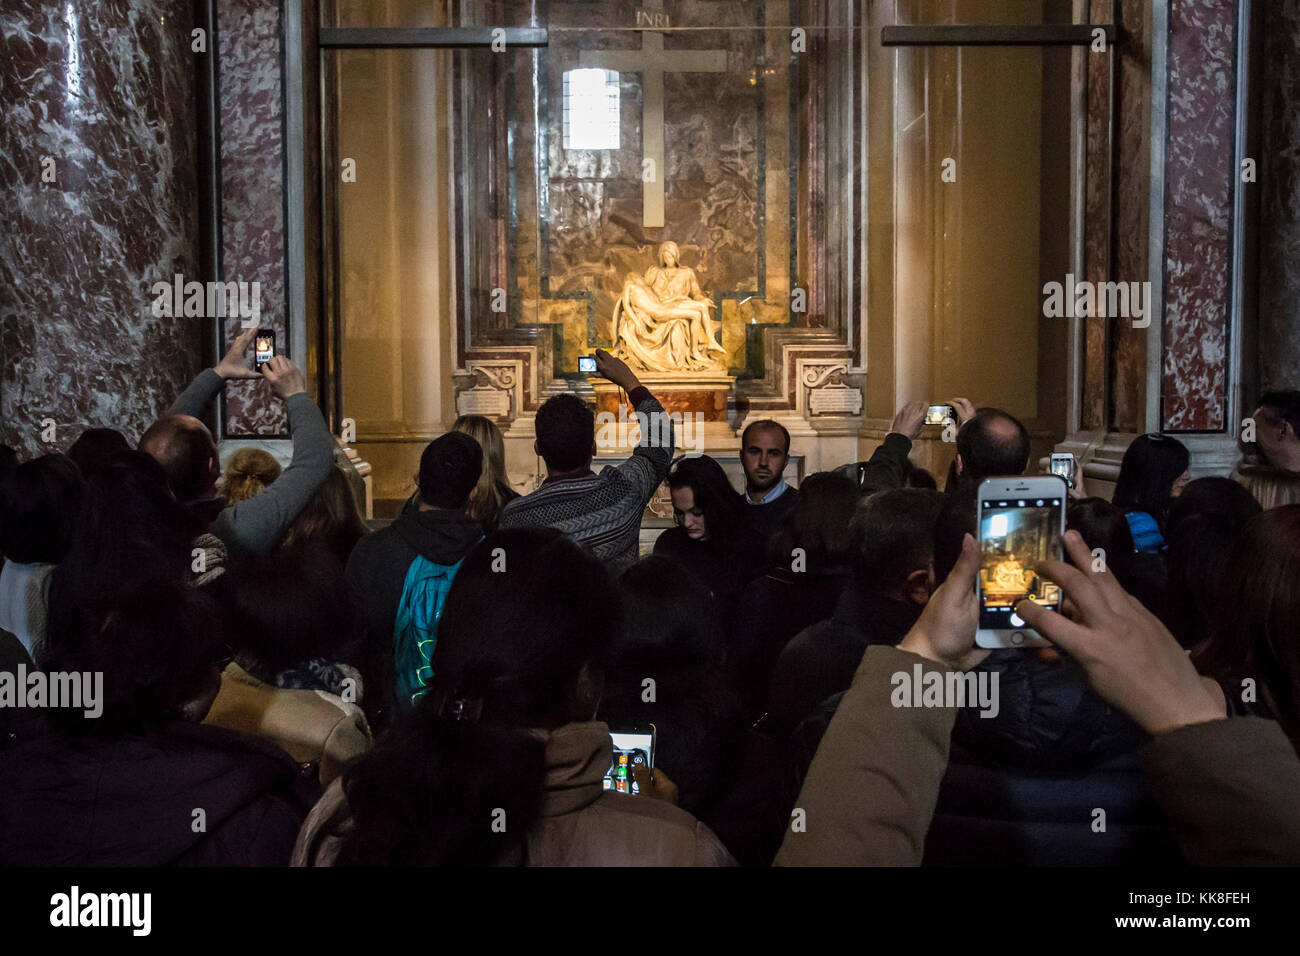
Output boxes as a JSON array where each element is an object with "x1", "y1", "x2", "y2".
[{"x1": 342, "y1": 509, "x2": 482, "y2": 734}]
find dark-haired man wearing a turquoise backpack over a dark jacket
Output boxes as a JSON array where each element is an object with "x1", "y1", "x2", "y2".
[{"x1": 343, "y1": 432, "x2": 482, "y2": 731}]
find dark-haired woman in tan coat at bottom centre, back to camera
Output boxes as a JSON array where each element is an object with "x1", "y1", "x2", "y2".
[{"x1": 294, "y1": 528, "x2": 731, "y2": 866}]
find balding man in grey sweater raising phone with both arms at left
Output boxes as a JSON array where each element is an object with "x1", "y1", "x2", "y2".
[{"x1": 139, "y1": 329, "x2": 335, "y2": 558}]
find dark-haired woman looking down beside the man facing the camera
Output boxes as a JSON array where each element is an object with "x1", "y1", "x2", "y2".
[{"x1": 654, "y1": 455, "x2": 766, "y2": 628}]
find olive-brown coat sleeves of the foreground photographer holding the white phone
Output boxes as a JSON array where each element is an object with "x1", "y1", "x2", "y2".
[{"x1": 776, "y1": 646, "x2": 1300, "y2": 866}]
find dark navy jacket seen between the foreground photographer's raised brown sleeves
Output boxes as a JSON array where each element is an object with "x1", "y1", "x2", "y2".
[{"x1": 792, "y1": 650, "x2": 1182, "y2": 866}]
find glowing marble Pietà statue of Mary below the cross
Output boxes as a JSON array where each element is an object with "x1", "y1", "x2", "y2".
[{"x1": 614, "y1": 242, "x2": 727, "y2": 372}]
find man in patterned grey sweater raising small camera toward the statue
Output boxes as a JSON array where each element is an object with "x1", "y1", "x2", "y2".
[{"x1": 501, "y1": 349, "x2": 675, "y2": 574}]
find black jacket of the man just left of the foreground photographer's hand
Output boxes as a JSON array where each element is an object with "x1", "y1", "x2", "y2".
[{"x1": 767, "y1": 581, "x2": 920, "y2": 734}]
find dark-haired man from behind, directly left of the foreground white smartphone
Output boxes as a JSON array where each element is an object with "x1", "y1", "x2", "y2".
[{"x1": 767, "y1": 488, "x2": 943, "y2": 734}]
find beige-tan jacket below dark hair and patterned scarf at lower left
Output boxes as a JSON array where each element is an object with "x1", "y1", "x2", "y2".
[{"x1": 203, "y1": 661, "x2": 371, "y2": 787}]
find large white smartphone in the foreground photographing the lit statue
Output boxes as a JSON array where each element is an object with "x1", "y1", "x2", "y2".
[{"x1": 975, "y1": 475, "x2": 1067, "y2": 648}]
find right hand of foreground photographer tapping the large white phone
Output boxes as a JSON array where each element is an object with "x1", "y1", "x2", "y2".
[{"x1": 1015, "y1": 531, "x2": 1226, "y2": 735}]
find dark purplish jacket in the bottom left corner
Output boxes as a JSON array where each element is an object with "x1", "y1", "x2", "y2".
[{"x1": 0, "y1": 722, "x2": 320, "y2": 866}]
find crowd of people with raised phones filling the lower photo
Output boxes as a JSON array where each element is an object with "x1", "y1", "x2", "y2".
[{"x1": 0, "y1": 332, "x2": 1300, "y2": 866}]
